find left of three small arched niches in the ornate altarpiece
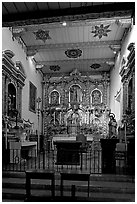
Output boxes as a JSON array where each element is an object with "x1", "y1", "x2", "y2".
[{"x1": 49, "y1": 90, "x2": 60, "y2": 105}]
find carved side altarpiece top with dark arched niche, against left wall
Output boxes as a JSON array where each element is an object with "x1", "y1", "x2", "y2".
[{"x1": 2, "y1": 50, "x2": 26, "y2": 119}]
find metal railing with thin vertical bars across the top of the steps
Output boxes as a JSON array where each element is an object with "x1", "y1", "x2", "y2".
[{"x1": 2, "y1": 149, "x2": 134, "y2": 174}]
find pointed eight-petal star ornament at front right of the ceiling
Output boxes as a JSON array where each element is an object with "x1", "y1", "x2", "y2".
[{"x1": 91, "y1": 24, "x2": 111, "y2": 39}]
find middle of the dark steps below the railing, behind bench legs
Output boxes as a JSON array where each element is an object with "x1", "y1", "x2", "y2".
[{"x1": 2, "y1": 179, "x2": 135, "y2": 194}]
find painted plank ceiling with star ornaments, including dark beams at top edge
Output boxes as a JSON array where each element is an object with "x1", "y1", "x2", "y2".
[{"x1": 2, "y1": 2, "x2": 134, "y2": 74}]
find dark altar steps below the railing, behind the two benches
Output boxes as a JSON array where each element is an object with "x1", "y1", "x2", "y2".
[{"x1": 2, "y1": 172, "x2": 135, "y2": 202}]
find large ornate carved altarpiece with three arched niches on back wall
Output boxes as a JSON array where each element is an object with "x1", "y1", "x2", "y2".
[{"x1": 42, "y1": 69, "x2": 110, "y2": 148}]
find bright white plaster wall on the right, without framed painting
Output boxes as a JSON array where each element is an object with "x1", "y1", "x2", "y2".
[{"x1": 110, "y1": 26, "x2": 135, "y2": 123}]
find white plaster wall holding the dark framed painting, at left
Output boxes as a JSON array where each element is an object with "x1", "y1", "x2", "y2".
[{"x1": 2, "y1": 28, "x2": 42, "y2": 132}]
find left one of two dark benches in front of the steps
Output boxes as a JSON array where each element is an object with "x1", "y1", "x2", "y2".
[{"x1": 26, "y1": 170, "x2": 55, "y2": 201}]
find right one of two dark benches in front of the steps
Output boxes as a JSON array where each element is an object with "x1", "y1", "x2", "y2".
[{"x1": 60, "y1": 171, "x2": 90, "y2": 197}]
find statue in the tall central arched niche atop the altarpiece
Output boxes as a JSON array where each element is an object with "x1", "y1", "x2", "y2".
[{"x1": 70, "y1": 85, "x2": 82, "y2": 103}]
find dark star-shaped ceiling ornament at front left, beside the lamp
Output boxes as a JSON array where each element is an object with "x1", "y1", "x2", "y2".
[{"x1": 33, "y1": 29, "x2": 51, "y2": 43}]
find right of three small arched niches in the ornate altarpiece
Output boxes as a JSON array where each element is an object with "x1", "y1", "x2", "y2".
[{"x1": 90, "y1": 88, "x2": 103, "y2": 105}]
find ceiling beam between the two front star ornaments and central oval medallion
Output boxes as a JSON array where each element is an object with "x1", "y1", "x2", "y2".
[{"x1": 27, "y1": 40, "x2": 121, "y2": 52}]
